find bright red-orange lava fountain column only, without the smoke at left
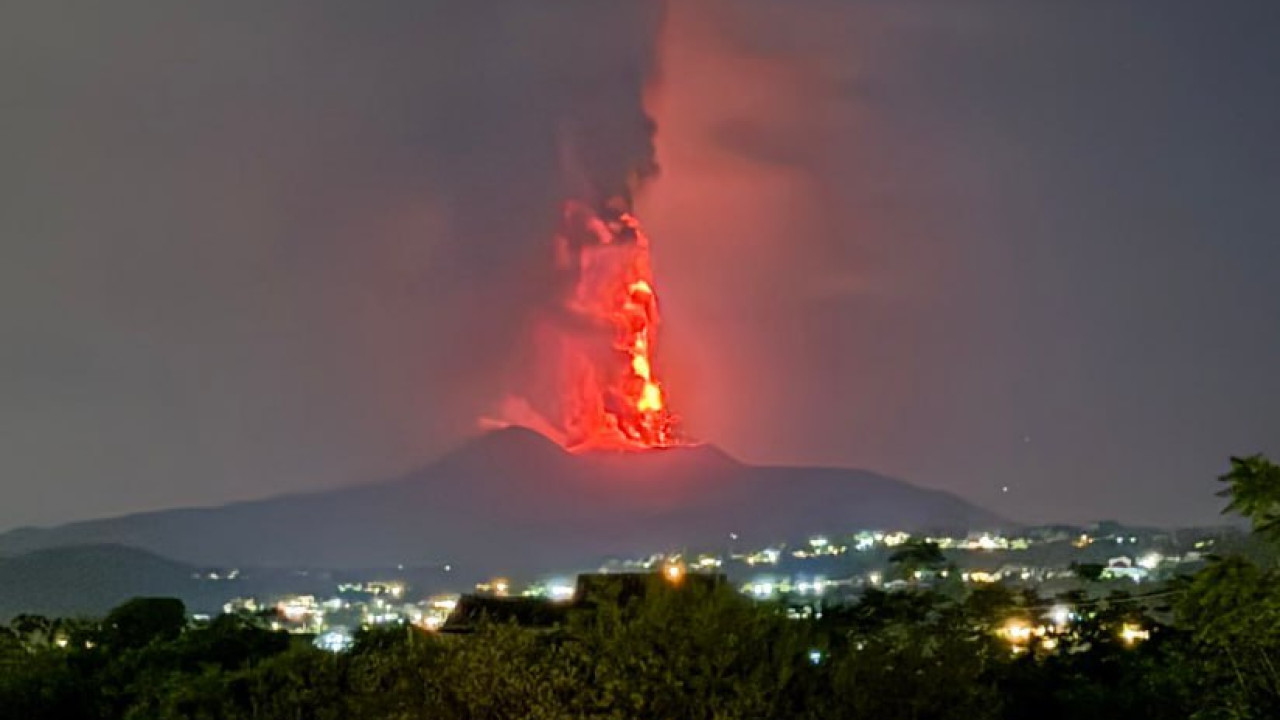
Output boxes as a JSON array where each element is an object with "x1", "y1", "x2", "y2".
[{"x1": 556, "y1": 197, "x2": 678, "y2": 448}]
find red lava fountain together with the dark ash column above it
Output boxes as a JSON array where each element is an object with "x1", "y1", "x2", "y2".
[{"x1": 478, "y1": 3, "x2": 678, "y2": 450}]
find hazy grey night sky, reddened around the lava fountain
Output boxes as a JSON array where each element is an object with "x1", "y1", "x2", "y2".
[{"x1": 0, "y1": 0, "x2": 1280, "y2": 529}]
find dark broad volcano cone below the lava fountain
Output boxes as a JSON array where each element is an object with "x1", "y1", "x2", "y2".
[{"x1": 0, "y1": 429, "x2": 1009, "y2": 579}]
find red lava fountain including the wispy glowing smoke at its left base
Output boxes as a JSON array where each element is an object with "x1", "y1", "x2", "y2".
[{"x1": 483, "y1": 196, "x2": 684, "y2": 451}]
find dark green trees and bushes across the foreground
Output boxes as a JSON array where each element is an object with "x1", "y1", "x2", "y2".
[{"x1": 0, "y1": 457, "x2": 1280, "y2": 720}]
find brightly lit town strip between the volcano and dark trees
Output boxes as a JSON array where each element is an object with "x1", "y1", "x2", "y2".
[{"x1": 197, "y1": 523, "x2": 1228, "y2": 651}]
